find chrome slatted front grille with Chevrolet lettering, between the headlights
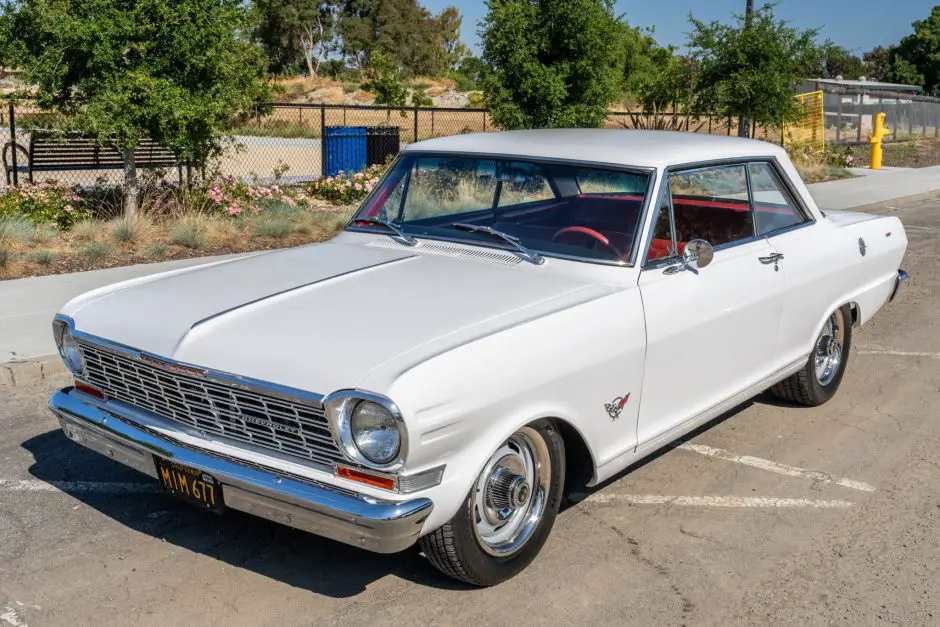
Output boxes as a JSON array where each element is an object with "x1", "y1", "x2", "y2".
[{"x1": 79, "y1": 342, "x2": 349, "y2": 466}]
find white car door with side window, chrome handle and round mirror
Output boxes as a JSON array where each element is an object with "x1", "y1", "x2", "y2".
[{"x1": 637, "y1": 164, "x2": 784, "y2": 446}]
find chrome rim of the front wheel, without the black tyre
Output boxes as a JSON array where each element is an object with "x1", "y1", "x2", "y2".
[{"x1": 470, "y1": 427, "x2": 552, "y2": 557}]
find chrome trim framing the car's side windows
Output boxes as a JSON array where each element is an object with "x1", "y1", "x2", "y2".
[{"x1": 640, "y1": 156, "x2": 816, "y2": 270}]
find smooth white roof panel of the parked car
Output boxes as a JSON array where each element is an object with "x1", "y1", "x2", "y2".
[{"x1": 404, "y1": 128, "x2": 786, "y2": 168}]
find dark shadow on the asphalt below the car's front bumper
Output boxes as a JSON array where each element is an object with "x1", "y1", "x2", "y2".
[{"x1": 22, "y1": 429, "x2": 478, "y2": 598}]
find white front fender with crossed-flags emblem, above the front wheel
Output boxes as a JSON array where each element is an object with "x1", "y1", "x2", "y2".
[{"x1": 374, "y1": 288, "x2": 646, "y2": 532}]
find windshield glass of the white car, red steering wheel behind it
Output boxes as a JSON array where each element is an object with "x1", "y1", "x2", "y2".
[{"x1": 351, "y1": 154, "x2": 650, "y2": 262}]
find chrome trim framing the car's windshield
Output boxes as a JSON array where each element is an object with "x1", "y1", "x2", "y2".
[{"x1": 343, "y1": 155, "x2": 656, "y2": 268}]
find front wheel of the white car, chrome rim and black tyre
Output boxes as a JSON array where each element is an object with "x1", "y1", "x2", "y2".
[{"x1": 420, "y1": 421, "x2": 565, "y2": 586}]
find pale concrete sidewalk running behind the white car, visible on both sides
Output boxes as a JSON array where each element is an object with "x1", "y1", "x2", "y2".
[{"x1": 0, "y1": 166, "x2": 940, "y2": 378}]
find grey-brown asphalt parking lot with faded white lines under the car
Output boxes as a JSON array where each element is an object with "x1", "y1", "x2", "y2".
[{"x1": 0, "y1": 194, "x2": 940, "y2": 627}]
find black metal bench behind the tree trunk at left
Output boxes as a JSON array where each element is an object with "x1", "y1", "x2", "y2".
[{"x1": 2, "y1": 130, "x2": 183, "y2": 185}]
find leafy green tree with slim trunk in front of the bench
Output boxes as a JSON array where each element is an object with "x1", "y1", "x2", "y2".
[{"x1": 0, "y1": 0, "x2": 266, "y2": 215}]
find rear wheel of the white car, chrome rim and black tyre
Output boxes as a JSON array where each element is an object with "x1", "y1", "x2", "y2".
[{"x1": 771, "y1": 305, "x2": 852, "y2": 407}]
